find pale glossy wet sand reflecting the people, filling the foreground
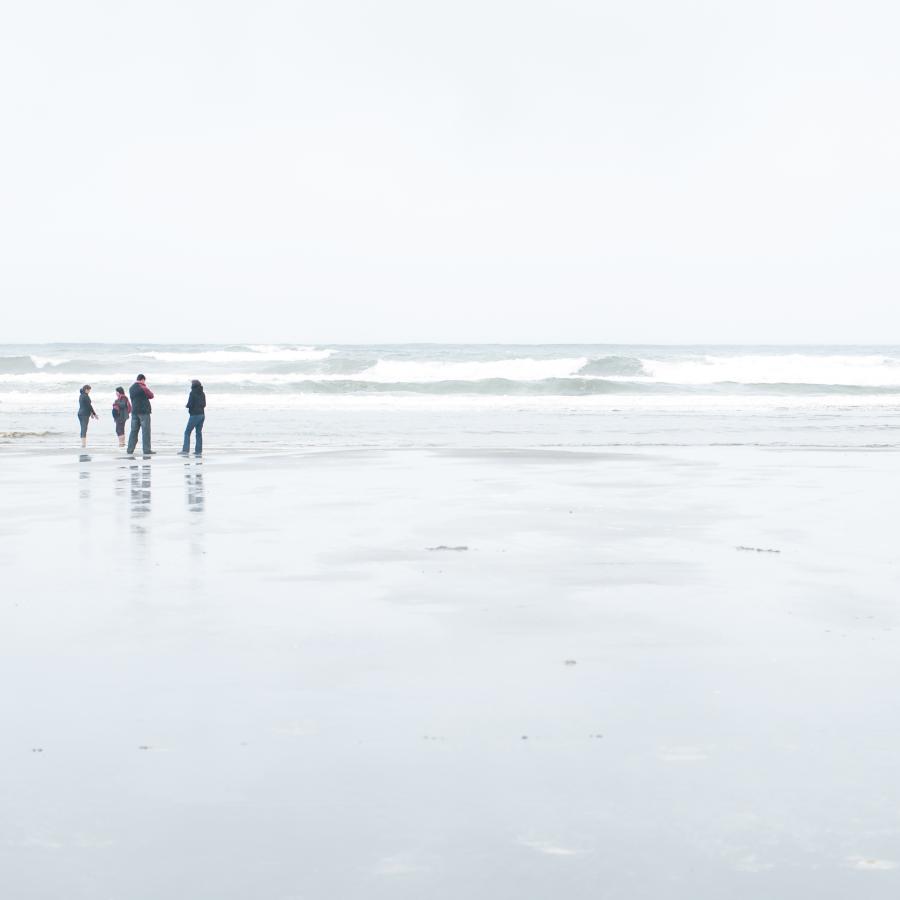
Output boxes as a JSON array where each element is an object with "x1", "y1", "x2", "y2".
[{"x1": 0, "y1": 448, "x2": 900, "y2": 900}]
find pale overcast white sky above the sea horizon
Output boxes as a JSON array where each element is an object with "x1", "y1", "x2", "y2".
[{"x1": 0, "y1": 0, "x2": 900, "y2": 343}]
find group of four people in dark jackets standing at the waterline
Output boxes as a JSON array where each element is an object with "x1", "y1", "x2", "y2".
[{"x1": 78, "y1": 375, "x2": 206, "y2": 456}]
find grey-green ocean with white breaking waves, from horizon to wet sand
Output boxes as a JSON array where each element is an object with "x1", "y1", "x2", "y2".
[{"x1": 0, "y1": 344, "x2": 900, "y2": 451}]
